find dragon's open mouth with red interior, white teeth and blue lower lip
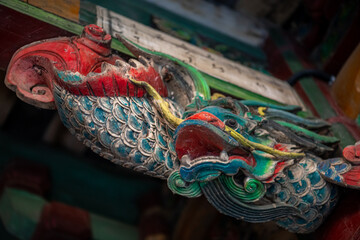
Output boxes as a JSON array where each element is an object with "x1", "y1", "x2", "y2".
[{"x1": 175, "y1": 113, "x2": 255, "y2": 182}]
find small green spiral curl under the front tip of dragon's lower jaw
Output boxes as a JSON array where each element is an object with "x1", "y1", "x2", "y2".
[{"x1": 167, "y1": 171, "x2": 201, "y2": 198}]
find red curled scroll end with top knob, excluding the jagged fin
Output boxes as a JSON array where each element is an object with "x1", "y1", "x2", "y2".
[{"x1": 5, "y1": 25, "x2": 120, "y2": 108}]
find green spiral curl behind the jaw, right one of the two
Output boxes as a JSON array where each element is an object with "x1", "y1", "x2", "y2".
[{"x1": 219, "y1": 175, "x2": 266, "y2": 202}]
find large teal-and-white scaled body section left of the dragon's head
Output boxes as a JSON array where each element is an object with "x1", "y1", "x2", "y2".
[{"x1": 54, "y1": 85, "x2": 182, "y2": 179}]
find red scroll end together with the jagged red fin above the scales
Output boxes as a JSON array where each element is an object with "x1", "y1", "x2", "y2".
[{"x1": 5, "y1": 25, "x2": 167, "y2": 109}]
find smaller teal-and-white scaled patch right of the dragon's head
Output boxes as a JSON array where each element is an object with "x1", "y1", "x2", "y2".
[{"x1": 266, "y1": 156, "x2": 338, "y2": 233}]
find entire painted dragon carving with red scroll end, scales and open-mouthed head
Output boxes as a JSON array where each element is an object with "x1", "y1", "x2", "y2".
[{"x1": 5, "y1": 25, "x2": 360, "y2": 233}]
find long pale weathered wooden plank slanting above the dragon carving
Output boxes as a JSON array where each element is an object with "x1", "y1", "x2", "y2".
[{"x1": 97, "y1": 6, "x2": 304, "y2": 106}]
